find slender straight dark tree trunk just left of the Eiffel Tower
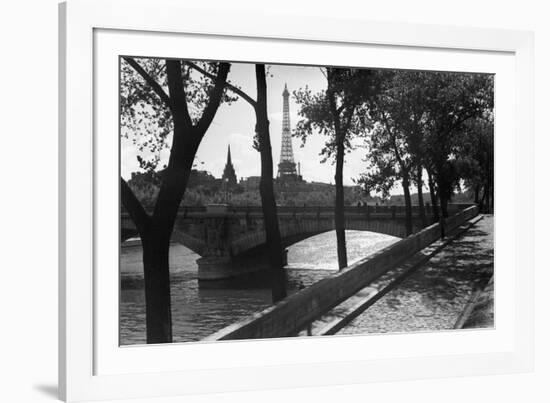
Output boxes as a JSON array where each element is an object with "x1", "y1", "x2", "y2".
[{"x1": 256, "y1": 64, "x2": 286, "y2": 303}]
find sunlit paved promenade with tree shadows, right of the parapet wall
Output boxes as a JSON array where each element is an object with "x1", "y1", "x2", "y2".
[{"x1": 338, "y1": 215, "x2": 494, "y2": 334}]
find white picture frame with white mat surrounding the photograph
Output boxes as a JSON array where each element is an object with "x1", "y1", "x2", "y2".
[{"x1": 59, "y1": 0, "x2": 534, "y2": 401}]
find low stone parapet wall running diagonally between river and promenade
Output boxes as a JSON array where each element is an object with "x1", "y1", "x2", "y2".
[{"x1": 205, "y1": 206, "x2": 479, "y2": 341}]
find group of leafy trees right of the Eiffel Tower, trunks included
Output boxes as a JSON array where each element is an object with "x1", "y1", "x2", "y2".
[{"x1": 294, "y1": 68, "x2": 493, "y2": 269}]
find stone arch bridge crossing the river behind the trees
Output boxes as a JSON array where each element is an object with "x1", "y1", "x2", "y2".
[{"x1": 121, "y1": 205, "x2": 465, "y2": 280}]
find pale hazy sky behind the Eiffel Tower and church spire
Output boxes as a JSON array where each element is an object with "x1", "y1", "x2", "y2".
[{"x1": 121, "y1": 63, "x2": 365, "y2": 185}]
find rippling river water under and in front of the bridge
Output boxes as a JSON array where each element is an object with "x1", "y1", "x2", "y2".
[{"x1": 120, "y1": 231, "x2": 398, "y2": 345}]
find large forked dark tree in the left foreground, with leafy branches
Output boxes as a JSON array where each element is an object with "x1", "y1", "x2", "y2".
[{"x1": 120, "y1": 57, "x2": 230, "y2": 343}]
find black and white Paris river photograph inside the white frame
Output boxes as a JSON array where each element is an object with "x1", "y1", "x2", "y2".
[{"x1": 119, "y1": 56, "x2": 494, "y2": 345}]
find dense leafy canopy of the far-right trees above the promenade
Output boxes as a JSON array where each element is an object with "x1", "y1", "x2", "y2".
[{"x1": 358, "y1": 70, "x2": 493, "y2": 221}]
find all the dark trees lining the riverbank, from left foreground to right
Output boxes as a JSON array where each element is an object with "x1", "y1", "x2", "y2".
[{"x1": 121, "y1": 57, "x2": 493, "y2": 343}]
